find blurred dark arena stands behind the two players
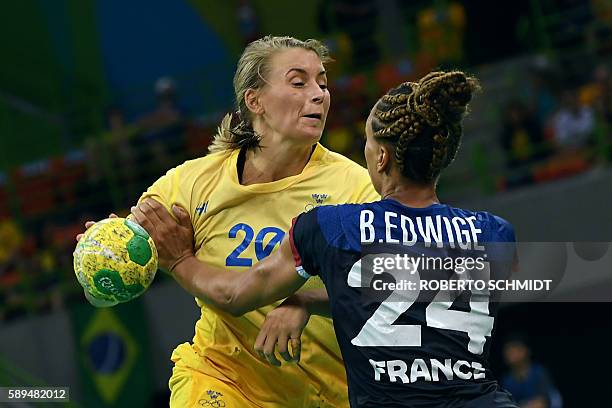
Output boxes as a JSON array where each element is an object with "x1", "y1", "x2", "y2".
[{"x1": 0, "y1": 0, "x2": 612, "y2": 407}]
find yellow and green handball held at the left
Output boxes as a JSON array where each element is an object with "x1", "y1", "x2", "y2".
[{"x1": 74, "y1": 218, "x2": 157, "y2": 305}]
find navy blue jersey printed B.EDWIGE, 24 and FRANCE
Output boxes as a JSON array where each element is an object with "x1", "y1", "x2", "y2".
[{"x1": 290, "y1": 199, "x2": 515, "y2": 407}]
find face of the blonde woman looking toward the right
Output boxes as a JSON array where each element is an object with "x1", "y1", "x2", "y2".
[{"x1": 258, "y1": 48, "x2": 330, "y2": 144}]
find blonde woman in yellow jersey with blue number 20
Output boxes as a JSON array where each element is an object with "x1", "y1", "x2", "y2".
[{"x1": 81, "y1": 37, "x2": 380, "y2": 408}]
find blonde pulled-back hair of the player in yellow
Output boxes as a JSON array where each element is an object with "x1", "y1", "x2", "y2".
[{"x1": 209, "y1": 35, "x2": 331, "y2": 153}]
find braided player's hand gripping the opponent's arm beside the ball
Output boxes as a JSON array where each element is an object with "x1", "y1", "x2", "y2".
[{"x1": 132, "y1": 198, "x2": 193, "y2": 272}]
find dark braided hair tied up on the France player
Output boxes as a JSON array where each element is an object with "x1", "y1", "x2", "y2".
[{"x1": 372, "y1": 71, "x2": 480, "y2": 183}]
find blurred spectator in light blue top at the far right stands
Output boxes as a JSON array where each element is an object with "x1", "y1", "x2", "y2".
[{"x1": 553, "y1": 91, "x2": 595, "y2": 150}]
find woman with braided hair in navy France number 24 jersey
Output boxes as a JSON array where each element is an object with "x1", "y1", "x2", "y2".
[{"x1": 134, "y1": 71, "x2": 516, "y2": 408}]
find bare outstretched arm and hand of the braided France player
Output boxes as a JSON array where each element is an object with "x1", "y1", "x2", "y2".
[{"x1": 132, "y1": 199, "x2": 306, "y2": 316}]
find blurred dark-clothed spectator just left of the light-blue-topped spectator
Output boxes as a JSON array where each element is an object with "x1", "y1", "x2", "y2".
[{"x1": 501, "y1": 100, "x2": 549, "y2": 167}]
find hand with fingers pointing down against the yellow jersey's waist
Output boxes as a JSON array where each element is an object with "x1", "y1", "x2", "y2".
[{"x1": 255, "y1": 296, "x2": 310, "y2": 366}]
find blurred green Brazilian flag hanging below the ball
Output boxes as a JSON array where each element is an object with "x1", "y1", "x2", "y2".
[{"x1": 71, "y1": 299, "x2": 154, "y2": 408}]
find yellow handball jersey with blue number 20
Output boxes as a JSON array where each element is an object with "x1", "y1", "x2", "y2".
[{"x1": 142, "y1": 144, "x2": 380, "y2": 407}]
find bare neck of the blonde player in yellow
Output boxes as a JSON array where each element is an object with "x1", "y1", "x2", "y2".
[{"x1": 240, "y1": 142, "x2": 314, "y2": 186}]
